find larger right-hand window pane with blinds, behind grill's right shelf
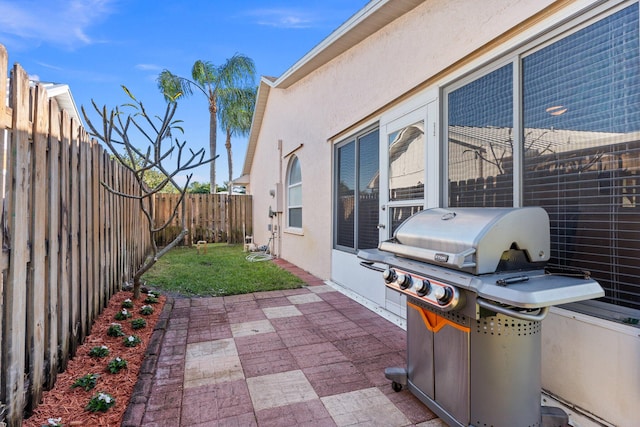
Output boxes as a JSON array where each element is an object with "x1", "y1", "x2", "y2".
[{"x1": 522, "y1": 4, "x2": 640, "y2": 309}]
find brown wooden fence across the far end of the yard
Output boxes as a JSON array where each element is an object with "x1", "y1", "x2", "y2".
[{"x1": 154, "y1": 194, "x2": 253, "y2": 246}]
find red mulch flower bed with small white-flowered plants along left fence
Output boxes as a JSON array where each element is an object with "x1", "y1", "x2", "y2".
[{"x1": 23, "y1": 291, "x2": 166, "y2": 427}]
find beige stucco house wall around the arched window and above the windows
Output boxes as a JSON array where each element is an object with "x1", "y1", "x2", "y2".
[{"x1": 251, "y1": 0, "x2": 551, "y2": 279}]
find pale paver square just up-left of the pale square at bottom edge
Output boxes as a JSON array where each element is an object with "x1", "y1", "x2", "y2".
[{"x1": 247, "y1": 370, "x2": 318, "y2": 411}]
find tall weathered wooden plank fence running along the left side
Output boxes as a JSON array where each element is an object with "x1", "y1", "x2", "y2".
[{"x1": 0, "y1": 45, "x2": 149, "y2": 426}]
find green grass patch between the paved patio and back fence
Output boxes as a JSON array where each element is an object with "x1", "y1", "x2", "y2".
[{"x1": 142, "y1": 243, "x2": 303, "y2": 296}]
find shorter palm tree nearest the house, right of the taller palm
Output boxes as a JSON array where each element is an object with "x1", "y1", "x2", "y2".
[{"x1": 218, "y1": 87, "x2": 258, "y2": 187}]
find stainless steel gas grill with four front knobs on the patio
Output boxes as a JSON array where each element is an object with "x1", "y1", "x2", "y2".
[{"x1": 358, "y1": 207, "x2": 604, "y2": 427}]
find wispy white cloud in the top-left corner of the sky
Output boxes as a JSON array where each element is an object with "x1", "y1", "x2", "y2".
[{"x1": 0, "y1": 0, "x2": 115, "y2": 49}]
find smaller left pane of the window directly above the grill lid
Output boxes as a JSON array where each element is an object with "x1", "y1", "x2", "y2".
[{"x1": 447, "y1": 64, "x2": 513, "y2": 207}]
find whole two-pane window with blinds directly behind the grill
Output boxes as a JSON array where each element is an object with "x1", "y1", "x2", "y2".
[{"x1": 444, "y1": 3, "x2": 640, "y2": 310}]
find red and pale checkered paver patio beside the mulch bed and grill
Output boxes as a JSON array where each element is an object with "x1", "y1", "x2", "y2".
[{"x1": 122, "y1": 260, "x2": 444, "y2": 427}]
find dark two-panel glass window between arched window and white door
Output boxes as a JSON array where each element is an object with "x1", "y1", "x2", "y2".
[{"x1": 334, "y1": 129, "x2": 379, "y2": 251}]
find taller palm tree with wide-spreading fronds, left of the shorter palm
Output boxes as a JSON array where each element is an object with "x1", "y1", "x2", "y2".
[{"x1": 157, "y1": 54, "x2": 255, "y2": 193}]
